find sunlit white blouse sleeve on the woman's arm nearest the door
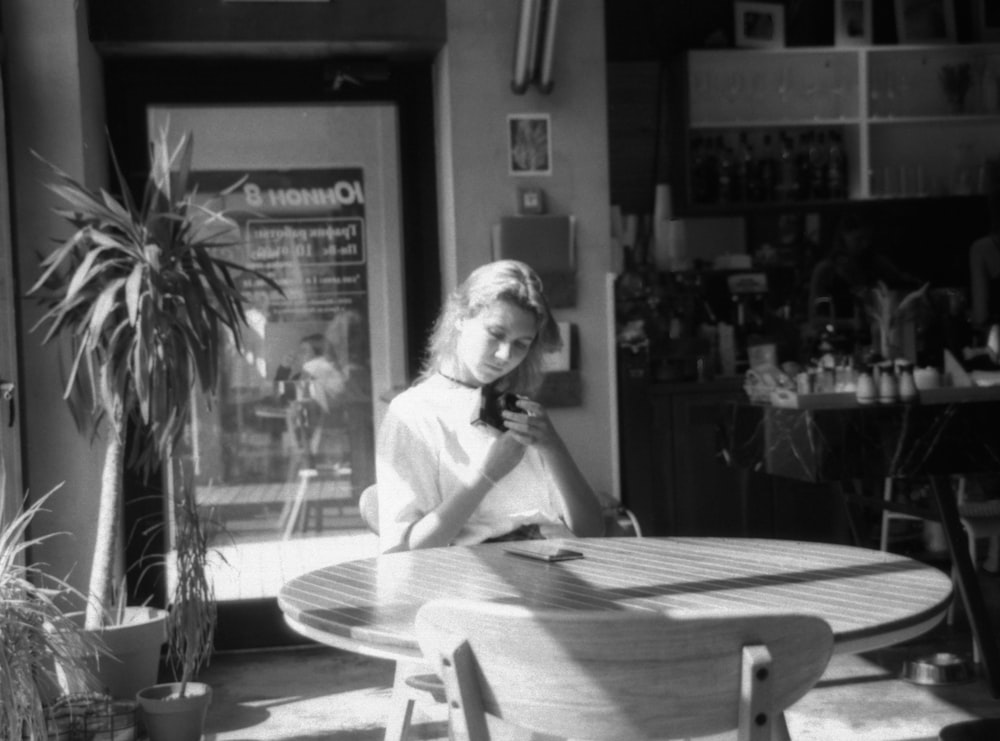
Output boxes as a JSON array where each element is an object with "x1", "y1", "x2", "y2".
[{"x1": 376, "y1": 397, "x2": 441, "y2": 553}]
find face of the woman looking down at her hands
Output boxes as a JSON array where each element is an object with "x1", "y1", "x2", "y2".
[{"x1": 455, "y1": 301, "x2": 538, "y2": 386}]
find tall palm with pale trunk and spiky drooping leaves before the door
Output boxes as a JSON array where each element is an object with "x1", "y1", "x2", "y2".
[{"x1": 29, "y1": 130, "x2": 280, "y2": 696}]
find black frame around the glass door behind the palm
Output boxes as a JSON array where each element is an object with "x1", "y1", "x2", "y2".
[{"x1": 105, "y1": 56, "x2": 441, "y2": 650}]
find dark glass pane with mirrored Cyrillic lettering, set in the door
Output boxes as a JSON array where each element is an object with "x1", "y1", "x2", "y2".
[{"x1": 186, "y1": 167, "x2": 374, "y2": 497}]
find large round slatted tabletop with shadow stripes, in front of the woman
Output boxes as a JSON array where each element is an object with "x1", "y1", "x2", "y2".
[{"x1": 278, "y1": 538, "x2": 952, "y2": 660}]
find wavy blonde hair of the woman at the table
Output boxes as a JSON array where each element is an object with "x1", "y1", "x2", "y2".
[{"x1": 420, "y1": 260, "x2": 562, "y2": 394}]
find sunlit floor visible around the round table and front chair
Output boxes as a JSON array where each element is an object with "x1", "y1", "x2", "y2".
[{"x1": 193, "y1": 575, "x2": 1000, "y2": 741}]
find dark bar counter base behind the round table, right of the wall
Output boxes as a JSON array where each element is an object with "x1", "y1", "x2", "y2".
[{"x1": 619, "y1": 357, "x2": 850, "y2": 543}]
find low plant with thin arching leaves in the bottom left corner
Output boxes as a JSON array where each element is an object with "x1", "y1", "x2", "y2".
[{"x1": 0, "y1": 486, "x2": 101, "y2": 739}]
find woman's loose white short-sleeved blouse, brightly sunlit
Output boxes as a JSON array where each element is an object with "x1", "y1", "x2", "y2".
[{"x1": 376, "y1": 375, "x2": 561, "y2": 551}]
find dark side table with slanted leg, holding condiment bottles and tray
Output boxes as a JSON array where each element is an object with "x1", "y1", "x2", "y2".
[{"x1": 722, "y1": 400, "x2": 1000, "y2": 697}]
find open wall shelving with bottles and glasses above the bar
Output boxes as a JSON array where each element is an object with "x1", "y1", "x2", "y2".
[{"x1": 682, "y1": 44, "x2": 1000, "y2": 208}]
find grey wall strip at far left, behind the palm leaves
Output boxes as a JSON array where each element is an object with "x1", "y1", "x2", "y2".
[{"x1": 0, "y1": 0, "x2": 106, "y2": 588}]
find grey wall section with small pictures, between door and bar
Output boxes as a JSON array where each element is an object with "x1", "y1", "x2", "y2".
[{"x1": 438, "y1": 0, "x2": 617, "y2": 500}]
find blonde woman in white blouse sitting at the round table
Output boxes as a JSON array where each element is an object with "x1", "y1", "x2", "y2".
[{"x1": 376, "y1": 260, "x2": 604, "y2": 552}]
